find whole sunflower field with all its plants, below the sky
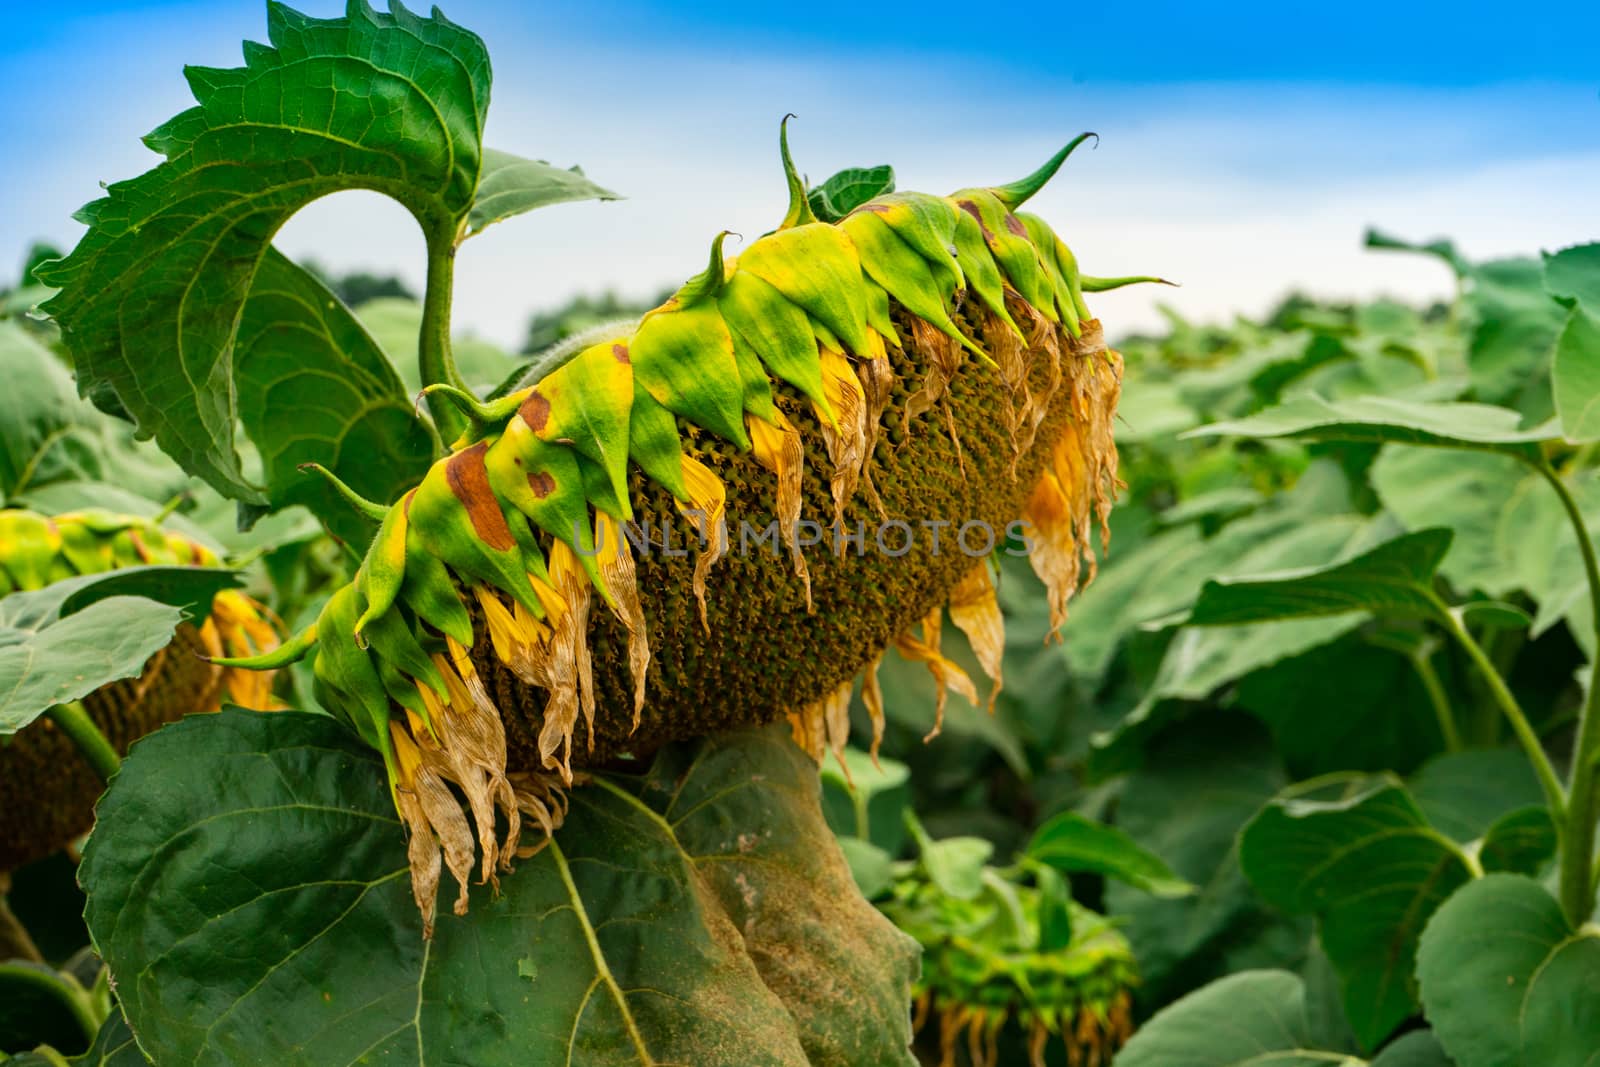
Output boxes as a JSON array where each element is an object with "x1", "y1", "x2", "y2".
[{"x1": 0, "y1": 0, "x2": 1600, "y2": 1067}]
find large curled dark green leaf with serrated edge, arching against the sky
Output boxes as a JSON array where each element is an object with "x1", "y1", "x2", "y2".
[{"x1": 42, "y1": 0, "x2": 490, "y2": 504}]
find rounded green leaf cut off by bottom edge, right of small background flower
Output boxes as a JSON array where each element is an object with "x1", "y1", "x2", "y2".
[{"x1": 1117, "y1": 971, "x2": 1362, "y2": 1067}]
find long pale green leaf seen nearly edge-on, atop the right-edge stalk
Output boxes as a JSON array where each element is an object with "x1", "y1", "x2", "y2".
[{"x1": 1184, "y1": 394, "x2": 1558, "y2": 461}]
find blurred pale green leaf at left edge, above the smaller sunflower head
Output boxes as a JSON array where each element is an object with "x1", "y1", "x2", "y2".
[{"x1": 0, "y1": 322, "x2": 186, "y2": 499}]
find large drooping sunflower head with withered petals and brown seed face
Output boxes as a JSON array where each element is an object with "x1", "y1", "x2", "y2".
[{"x1": 222, "y1": 120, "x2": 1152, "y2": 928}]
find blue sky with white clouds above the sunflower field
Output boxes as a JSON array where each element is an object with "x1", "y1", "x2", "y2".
[{"x1": 0, "y1": 0, "x2": 1600, "y2": 342}]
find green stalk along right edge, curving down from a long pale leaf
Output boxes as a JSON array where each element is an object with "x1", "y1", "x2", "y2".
[{"x1": 1539, "y1": 461, "x2": 1600, "y2": 926}]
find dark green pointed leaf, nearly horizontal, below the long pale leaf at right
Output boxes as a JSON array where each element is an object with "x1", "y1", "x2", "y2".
[{"x1": 1187, "y1": 530, "x2": 1451, "y2": 625}]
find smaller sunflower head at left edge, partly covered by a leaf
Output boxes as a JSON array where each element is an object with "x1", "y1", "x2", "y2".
[{"x1": 0, "y1": 509, "x2": 278, "y2": 870}]
